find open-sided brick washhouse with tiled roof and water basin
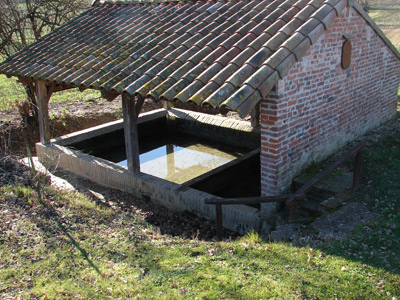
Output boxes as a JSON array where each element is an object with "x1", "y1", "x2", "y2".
[{"x1": 0, "y1": 0, "x2": 400, "y2": 233}]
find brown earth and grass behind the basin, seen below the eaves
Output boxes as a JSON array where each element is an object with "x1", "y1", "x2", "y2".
[{"x1": 0, "y1": 97, "x2": 249, "y2": 157}]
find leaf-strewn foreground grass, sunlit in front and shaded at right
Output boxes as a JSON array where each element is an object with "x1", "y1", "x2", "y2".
[{"x1": 0, "y1": 127, "x2": 400, "y2": 299}]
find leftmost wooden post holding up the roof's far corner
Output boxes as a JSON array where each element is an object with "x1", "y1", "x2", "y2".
[{"x1": 35, "y1": 80, "x2": 50, "y2": 144}]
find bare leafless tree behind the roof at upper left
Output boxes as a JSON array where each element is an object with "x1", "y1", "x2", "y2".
[{"x1": 0, "y1": 0, "x2": 88, "y2": 124}]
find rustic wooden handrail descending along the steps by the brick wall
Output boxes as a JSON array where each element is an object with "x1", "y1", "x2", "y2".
[{"x1": 205, "y1": 141, "x2": 366, "y2": 240}]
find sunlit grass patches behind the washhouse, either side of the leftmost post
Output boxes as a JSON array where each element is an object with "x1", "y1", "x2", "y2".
[{"x1": 0, "y1": 75, "x2": 101, "y2": 111}]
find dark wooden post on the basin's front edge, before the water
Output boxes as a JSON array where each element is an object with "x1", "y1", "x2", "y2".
[{"x1": 122, "y1": 93, "x2": 140, "y2": 173}]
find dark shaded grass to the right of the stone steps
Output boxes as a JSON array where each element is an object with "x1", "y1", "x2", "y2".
[{"x1": 294, "y1": 129, "x2": 400, "y2": 274}]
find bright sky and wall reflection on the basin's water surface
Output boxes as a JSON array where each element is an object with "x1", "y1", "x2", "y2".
[{"x1": 118, "y1": 143, "x2": 240, "y2": 184}]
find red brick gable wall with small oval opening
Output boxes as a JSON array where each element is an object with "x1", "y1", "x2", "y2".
[{"x1": 260, "y1": 7, "x2": 400, "y2": 195}]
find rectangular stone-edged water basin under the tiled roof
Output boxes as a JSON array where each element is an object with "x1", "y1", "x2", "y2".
[{"x1": 36, "y1": 109, "x2": 261, "y2": 233}]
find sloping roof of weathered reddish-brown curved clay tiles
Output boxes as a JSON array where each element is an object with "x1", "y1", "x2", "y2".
[{"x1": 0, "y1": 0, "x2": 396, "y2": 117}]
